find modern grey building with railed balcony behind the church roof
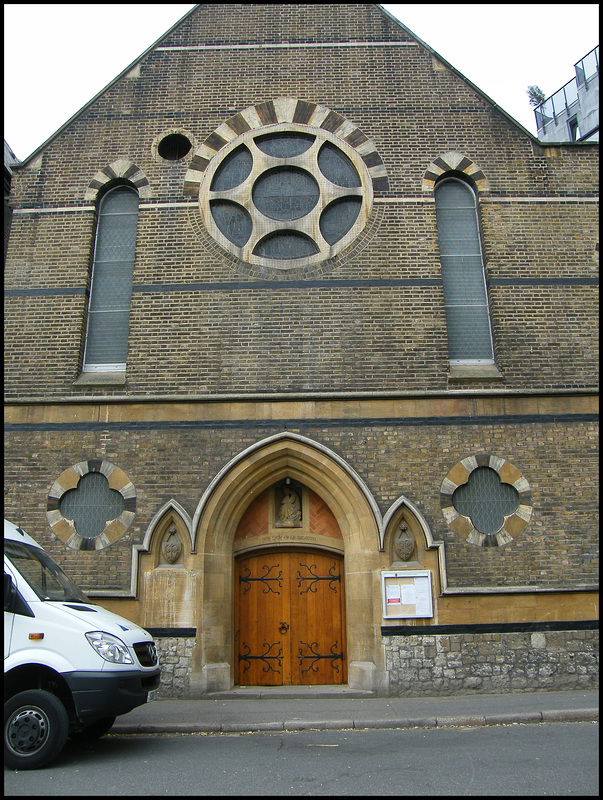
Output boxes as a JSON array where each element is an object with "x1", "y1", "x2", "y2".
[{"x1": 534, "y1": 45, "x2": 599, "y2": 142}]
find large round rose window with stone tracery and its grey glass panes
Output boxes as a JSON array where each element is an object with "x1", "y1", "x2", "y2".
[{"x1": 199, "y1": 123, "x2": 373, "y2": 270}]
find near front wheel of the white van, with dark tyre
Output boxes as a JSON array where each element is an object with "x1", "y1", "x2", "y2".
[{"x1": 4, "y1": 689, "x2": 69, "y2": 769}]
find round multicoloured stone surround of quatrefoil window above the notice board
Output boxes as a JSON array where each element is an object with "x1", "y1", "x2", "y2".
[{"x1": 440, "y1": 453, "x2": 532, "y2": 547}]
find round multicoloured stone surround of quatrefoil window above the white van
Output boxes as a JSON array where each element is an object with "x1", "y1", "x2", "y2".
[{"x1": 46, "y1": 459, "x2": 136, "y2": 550}]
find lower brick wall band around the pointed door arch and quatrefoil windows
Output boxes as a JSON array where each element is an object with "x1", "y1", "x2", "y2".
[{"x1": 5, "y1": 407, "x2": 598, "y2": 591}]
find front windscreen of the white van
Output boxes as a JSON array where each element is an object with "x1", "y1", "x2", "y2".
[{"x1": 4, "y1": 539, "x2": 90, "y2": 603}]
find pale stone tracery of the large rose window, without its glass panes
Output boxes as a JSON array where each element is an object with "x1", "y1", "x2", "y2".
[{"x1": 199, "y1": 122, "x2": 373, "y2": 271}]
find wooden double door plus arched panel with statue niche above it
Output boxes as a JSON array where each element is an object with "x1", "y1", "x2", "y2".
[{"x1": 233, "y1": 477, "x2": 347, "y2": 686}]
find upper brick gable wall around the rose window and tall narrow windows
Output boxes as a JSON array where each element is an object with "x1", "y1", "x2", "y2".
[{"x1": 5, "y1": 4, "x2": 598, "y2": 398}]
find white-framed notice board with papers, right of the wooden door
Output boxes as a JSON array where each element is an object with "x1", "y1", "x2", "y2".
[{"x1": 381, "y1": 569, "x2": 433, "y2": 619}]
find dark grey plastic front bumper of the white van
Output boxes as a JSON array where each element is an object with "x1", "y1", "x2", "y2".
[{"x1": 63, "y1": 668, "x2": 161, "y2": 722}]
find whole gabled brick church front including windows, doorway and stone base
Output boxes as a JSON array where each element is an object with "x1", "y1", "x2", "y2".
[{"x1": 4, "y1": 3, "x2": 599, "y2": 696}]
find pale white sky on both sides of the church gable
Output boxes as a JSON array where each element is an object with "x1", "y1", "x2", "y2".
[{"x1": 4, "y1": 3, "x2": 599, "y2": 159}]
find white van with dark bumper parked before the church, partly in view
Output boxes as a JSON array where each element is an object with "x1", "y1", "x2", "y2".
[{"x1": 4, "y1": 520, "x2": 160, "y2": 769}]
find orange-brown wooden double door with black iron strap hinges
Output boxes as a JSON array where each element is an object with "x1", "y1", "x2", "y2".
[{"x1": 235, "y1": 550, "x2": 347, "y2": 686}]
